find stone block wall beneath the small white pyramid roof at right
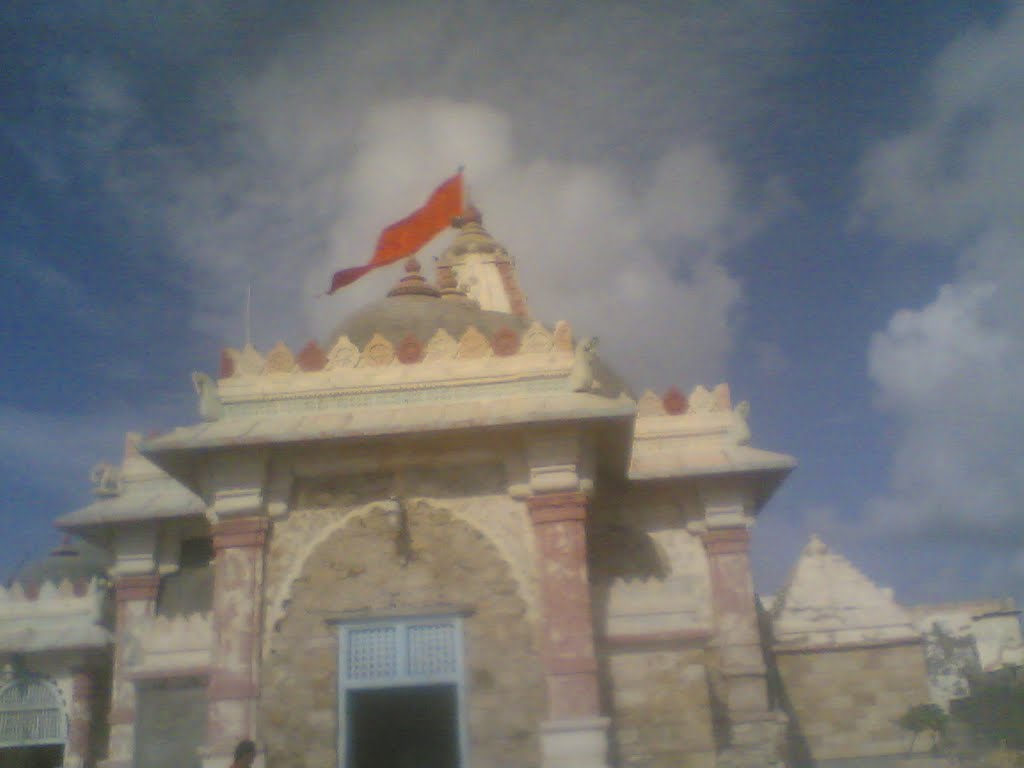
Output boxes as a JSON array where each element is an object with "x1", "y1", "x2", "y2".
[{"x1": 775, "y1": 643, "x2": 929, "y2": 760}]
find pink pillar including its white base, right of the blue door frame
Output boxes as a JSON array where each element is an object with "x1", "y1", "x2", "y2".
[{"x1": 527, "y1": 492, "x2": 608, "y2": 768}]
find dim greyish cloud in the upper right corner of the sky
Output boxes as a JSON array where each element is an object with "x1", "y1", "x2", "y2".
[{"x1": 858, "y1": 3, "x2": 1024, "y2": 242}]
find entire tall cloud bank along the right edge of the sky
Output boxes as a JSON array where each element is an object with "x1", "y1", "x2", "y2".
[{"x1": 858, "y1": 4, "x2": 1024, "y2": 602}]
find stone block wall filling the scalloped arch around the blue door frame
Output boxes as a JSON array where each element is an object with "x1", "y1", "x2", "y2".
[{"x1": 262, "y1": 502, "x2": 545, "y2": 767}]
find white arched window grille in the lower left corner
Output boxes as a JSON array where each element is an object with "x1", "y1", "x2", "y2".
[{"x1": 0, "y1": 678, "x2": 68, "y2": 746}]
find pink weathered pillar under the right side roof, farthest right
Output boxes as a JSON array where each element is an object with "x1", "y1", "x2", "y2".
[{"x1": 703, "y1": 525, "x2": 774, "y2": 742}]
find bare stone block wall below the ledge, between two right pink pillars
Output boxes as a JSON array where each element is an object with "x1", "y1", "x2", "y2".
[{"x1": 606, "y1": 649, "x2": 715, "y2": 768}]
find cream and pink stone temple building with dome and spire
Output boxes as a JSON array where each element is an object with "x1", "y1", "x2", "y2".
[{"x1": 0, "y1": 212, "x2": 1019, "y2": 768}]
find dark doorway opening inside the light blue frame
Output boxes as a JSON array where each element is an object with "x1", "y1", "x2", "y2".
[{"x1": 347, "y1": 685, "x2": 459, "y2": 768}]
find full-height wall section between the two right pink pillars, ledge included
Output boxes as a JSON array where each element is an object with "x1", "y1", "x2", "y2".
[{"x1": 590, "y1": 489, "x2": 716, "y2": 768}]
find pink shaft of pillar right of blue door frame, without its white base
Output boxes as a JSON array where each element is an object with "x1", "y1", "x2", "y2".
[{"x1": 527, "y1": 493, "x2": 600, "y2": 721}]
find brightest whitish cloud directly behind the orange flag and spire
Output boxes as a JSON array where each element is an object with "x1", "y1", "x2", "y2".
[{"x1": 296, "y1": 100, "x2": 753, "y2": 383}]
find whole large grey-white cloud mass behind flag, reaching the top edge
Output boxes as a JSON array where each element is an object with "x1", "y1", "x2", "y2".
[{"x1": 74, "y1": 3, "x2": 800, "y2": 388}]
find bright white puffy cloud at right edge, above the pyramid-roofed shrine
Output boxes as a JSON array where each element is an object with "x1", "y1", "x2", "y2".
[{"x1": 868, "y1": 232, "x2": 1024, "y2": 544}]
